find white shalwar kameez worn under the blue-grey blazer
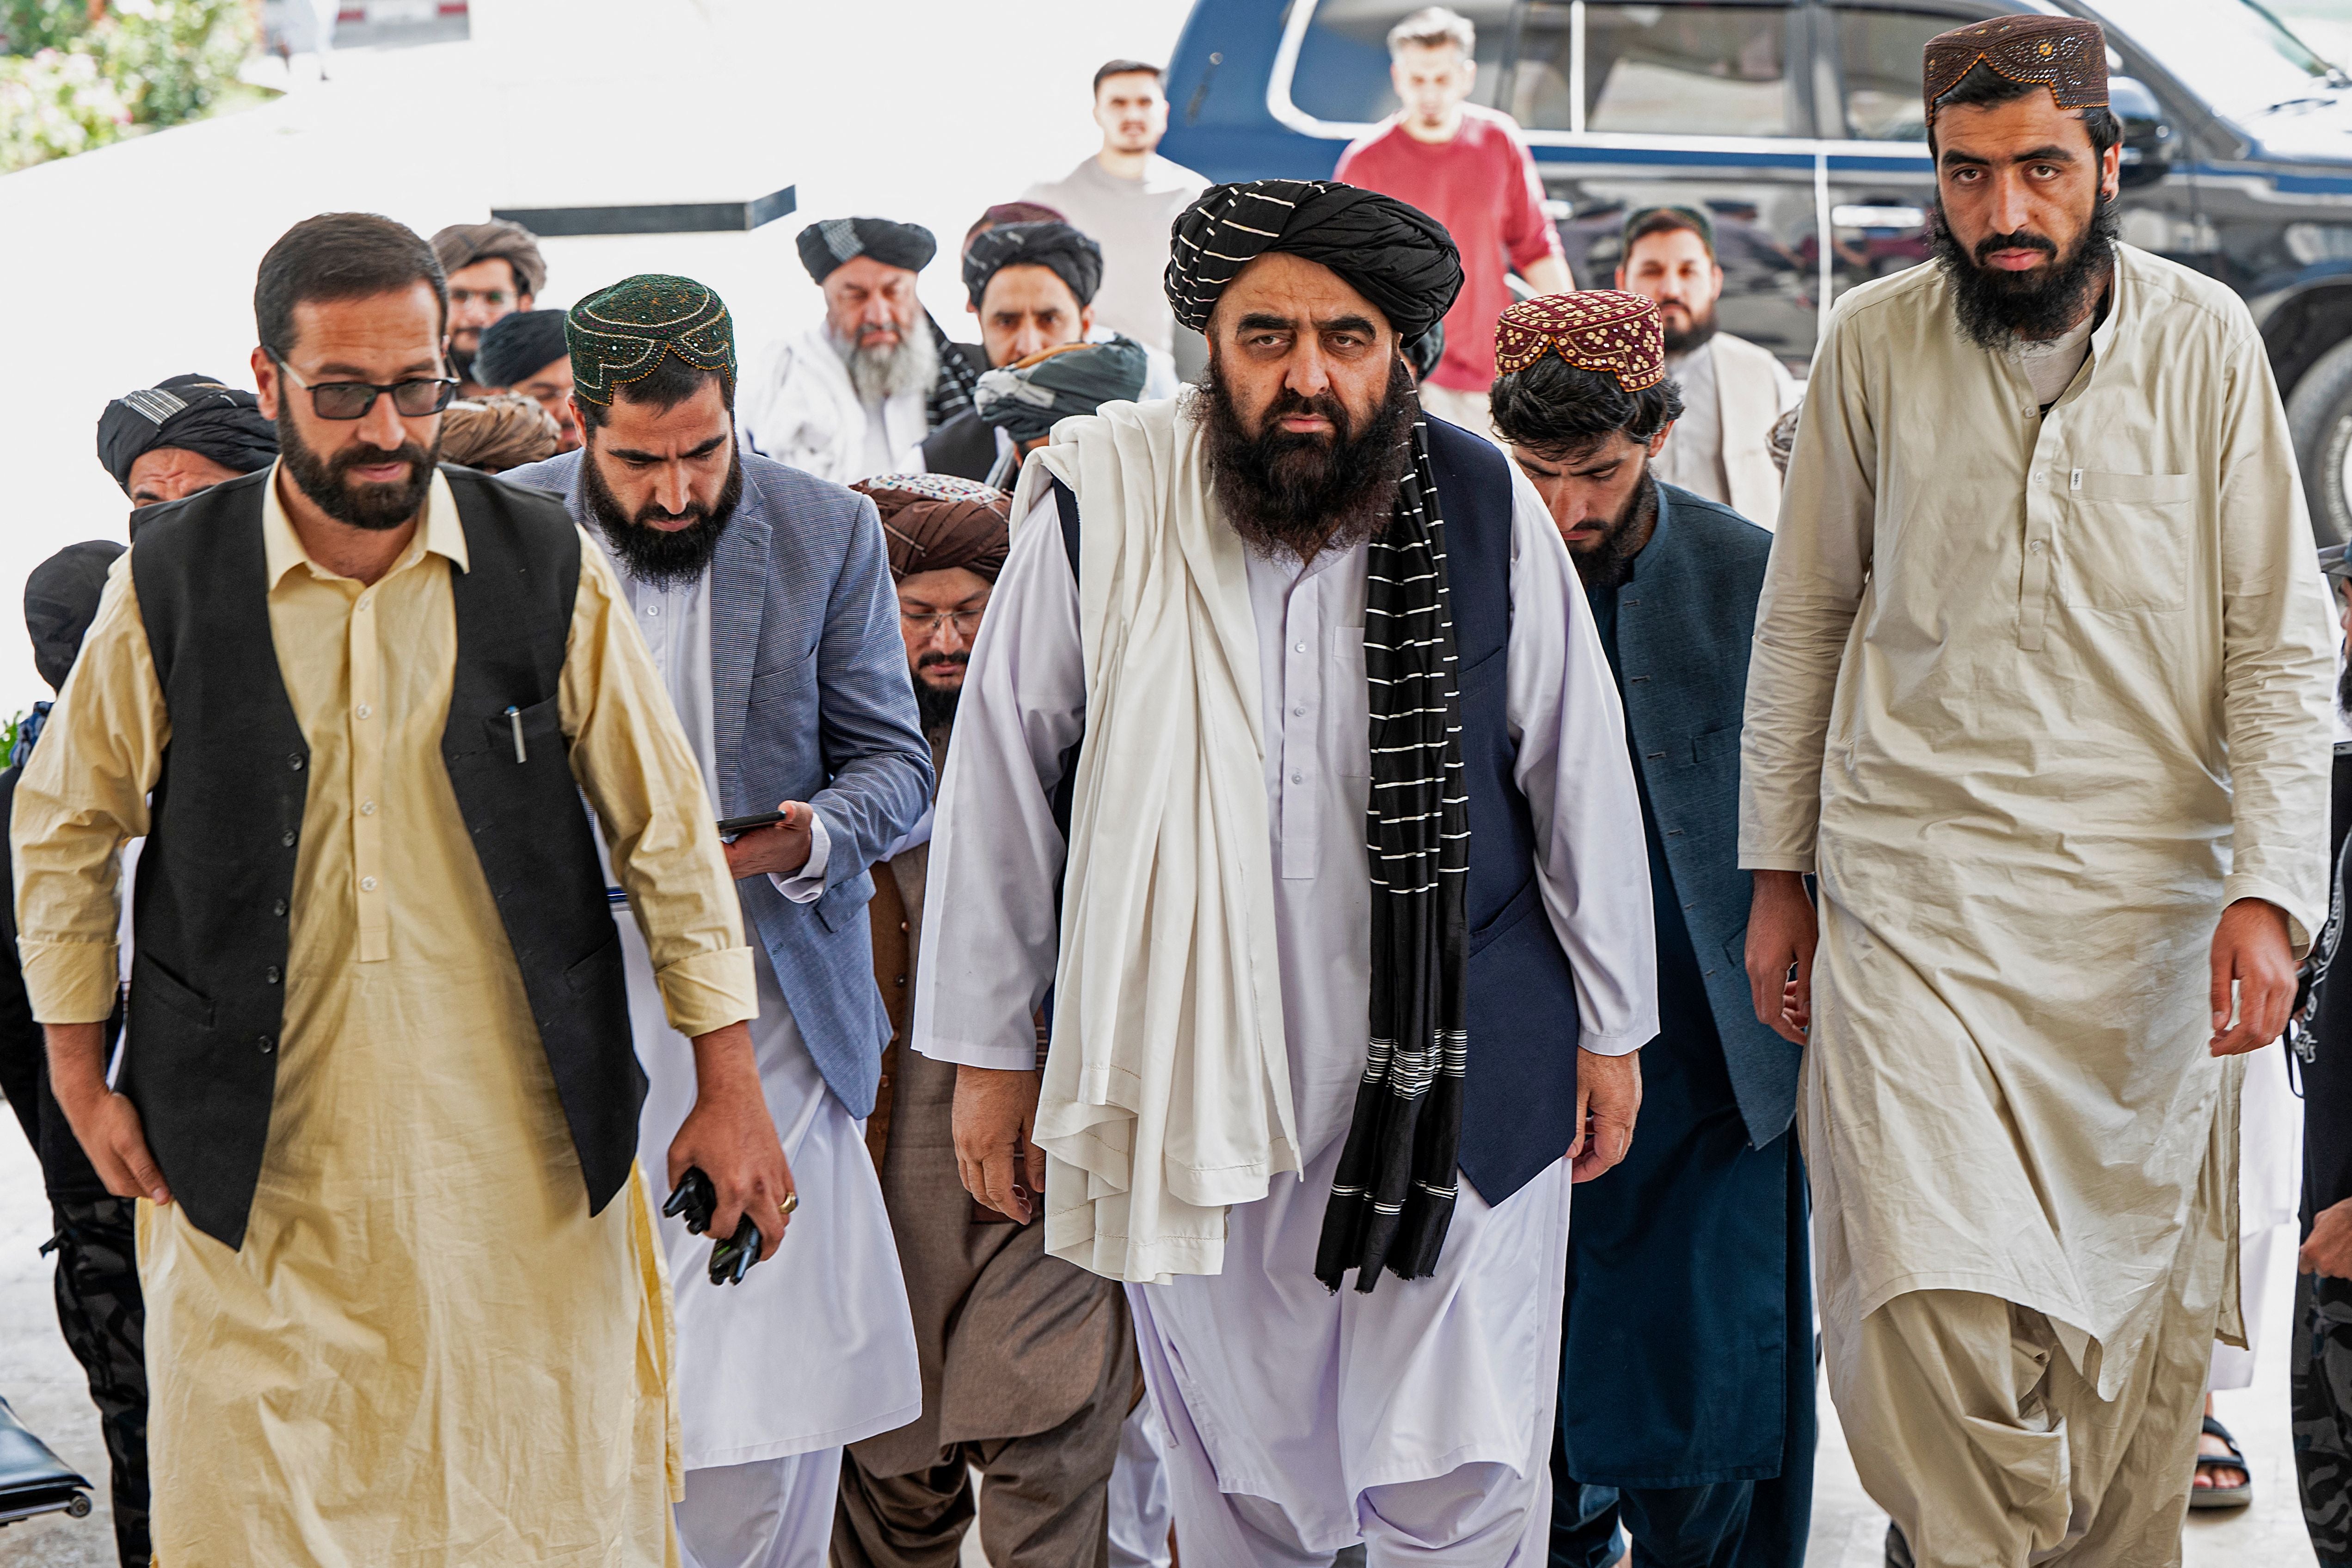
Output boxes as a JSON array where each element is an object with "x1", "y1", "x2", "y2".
[{"x1": 614, "y1": 560, "x2": 922, "y2": 1568}]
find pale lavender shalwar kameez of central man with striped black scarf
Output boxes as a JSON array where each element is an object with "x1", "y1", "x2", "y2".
[{"x1": 915, "y1": 446, "x2": 1656, "y2": 1568}]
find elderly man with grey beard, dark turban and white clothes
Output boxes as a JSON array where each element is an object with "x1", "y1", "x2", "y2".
[{"x1": 743, "y1": 219, "x2": 974, "y2": 484}]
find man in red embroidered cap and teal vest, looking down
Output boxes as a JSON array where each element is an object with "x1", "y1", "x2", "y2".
[{"x1": 1493, "y1": 289, "x2": 1813, "y2": 1568}]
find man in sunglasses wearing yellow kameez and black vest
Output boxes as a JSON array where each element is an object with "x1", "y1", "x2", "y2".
[{"x1": 12, "y1": 214, "x2": 795, "y2": 1566}]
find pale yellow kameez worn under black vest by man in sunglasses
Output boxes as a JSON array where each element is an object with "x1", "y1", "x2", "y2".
[{"x1": 14, "y1": 480, "x2": 755, "y2": 1568}]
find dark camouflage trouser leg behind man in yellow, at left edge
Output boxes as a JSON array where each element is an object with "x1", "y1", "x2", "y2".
[{"x1": 40, "y1": 1197, "x2": 153, "y2": 1568}]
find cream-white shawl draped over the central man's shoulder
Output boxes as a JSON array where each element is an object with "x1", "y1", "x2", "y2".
[{"x1": 1013, "y1": 397, "x2": 1301, "y2": 1281}]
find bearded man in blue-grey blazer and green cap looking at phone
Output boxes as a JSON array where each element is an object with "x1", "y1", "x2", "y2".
[{"x1": 508, "y1": 275, "x2": 931, "y2": 1568}]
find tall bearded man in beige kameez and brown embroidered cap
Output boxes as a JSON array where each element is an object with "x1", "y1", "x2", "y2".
[{"x1": 1740, "y1": 17, "x2": 2333, "y2": 1568}]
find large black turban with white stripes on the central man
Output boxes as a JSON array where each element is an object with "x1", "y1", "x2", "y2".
[{"x1": 1167, "y1": 178, "x2": 1463, "y2": 341}]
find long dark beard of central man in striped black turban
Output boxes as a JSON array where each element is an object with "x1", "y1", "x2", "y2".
[{"x1": 1199, "y1": 357, "x2": 1421, "y2": 562}]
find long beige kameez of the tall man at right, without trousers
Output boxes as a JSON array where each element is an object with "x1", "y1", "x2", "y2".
[{"x1": 1740, "y1": 247, "x2": 2333, "y2": 1561}]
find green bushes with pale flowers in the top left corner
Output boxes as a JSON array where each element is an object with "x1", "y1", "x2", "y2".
[{"x1": 0, "y1": 0, "x2": 256, "y2": 174}]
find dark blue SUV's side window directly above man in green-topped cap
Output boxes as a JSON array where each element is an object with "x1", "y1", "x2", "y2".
[{"x1": 1590, "y1": 2, "x2": 1792, "y2": 136}]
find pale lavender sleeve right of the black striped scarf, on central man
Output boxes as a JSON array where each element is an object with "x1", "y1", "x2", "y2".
[{"x1": 1505, "y1": 468, "x2": 1658, "y2": 1056}]
